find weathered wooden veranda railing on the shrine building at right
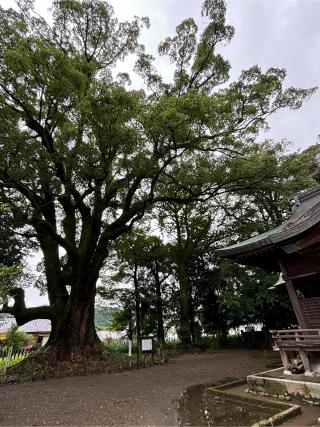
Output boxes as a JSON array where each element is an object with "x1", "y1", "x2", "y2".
[{"x1": 270, "y1": 329, "x2": 320, "y2": 351}]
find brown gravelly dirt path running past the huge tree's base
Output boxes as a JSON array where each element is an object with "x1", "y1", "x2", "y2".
[{"x1": 0, "y1": 350, "x2": 265, "y2": 426}]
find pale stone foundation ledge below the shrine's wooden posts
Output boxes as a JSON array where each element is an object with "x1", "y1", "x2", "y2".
[{"x1": 247, "y1": 368, "x2": 320, "y2": 402}]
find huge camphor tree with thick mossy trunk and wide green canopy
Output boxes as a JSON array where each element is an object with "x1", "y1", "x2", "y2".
[{"x1": 0, "y1": 0, "x2": 313, "y2": 359}]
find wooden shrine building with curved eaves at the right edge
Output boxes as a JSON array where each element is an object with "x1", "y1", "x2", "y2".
[{"x1": 216, "y1": 186, "x2": 320, "y2": 376}]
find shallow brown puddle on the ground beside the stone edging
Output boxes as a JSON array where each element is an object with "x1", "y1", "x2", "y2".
[{"x1": 177, "y1": 384, "x2": 279, "y2": 426}]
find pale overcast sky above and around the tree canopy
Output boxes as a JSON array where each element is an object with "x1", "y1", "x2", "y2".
[{"x1": 0, "y1": 0, "x2": 320, "y2": 305}]
